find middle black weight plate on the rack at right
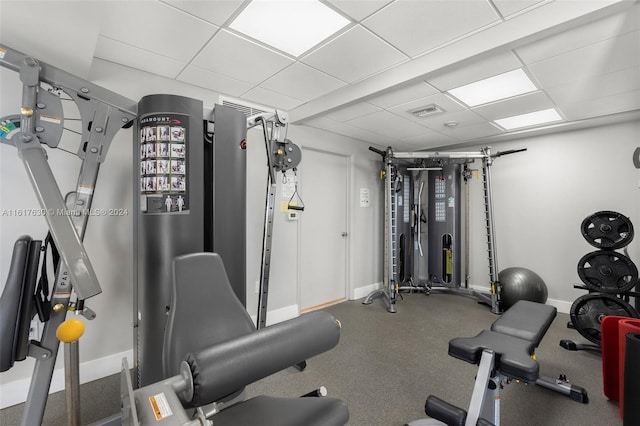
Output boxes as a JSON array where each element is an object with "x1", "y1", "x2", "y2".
[{"x1": 578, "y1": 250, "x2": 638, "y2": 293}]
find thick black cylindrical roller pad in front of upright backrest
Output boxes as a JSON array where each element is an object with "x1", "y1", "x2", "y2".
[{"x1": 185, "y1": 311, "x2": 340, "y2": 407}]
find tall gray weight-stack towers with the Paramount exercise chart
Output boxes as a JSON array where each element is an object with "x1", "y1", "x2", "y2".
[{"x1": 133, "y1": 94, "x2": 246, "y2": 386}]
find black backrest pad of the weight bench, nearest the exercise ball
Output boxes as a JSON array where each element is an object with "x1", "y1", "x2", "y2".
[{"x1": 491, "y1": 300, "x2": 557, "y2": 347}]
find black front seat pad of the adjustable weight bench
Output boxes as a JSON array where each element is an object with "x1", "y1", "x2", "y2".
[{"x1": 449, "y1": 330, "x2": 540, "y2": 383}]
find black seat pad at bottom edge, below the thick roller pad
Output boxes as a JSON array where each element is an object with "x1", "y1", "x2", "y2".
[{"x1": 211, "y1": 396, "x2": 349, "y2": 426}]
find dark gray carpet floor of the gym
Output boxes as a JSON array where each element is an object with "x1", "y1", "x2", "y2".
[{"x1": 0, "y1": 294, "x2": 622, "y2": 426}]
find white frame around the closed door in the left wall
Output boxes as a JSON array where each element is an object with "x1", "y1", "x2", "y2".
[{"x1": 296, "y1": 144, "x2": 355, "y2": 314}]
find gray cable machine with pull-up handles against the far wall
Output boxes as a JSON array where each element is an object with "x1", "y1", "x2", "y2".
[{"x1": 363, "y1": 147, "x2": 525, "y2": 314}]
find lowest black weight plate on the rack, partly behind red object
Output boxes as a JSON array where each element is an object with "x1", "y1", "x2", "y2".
[{"x1": 569, "y1": 293, "x2": 640, "y2": 345}]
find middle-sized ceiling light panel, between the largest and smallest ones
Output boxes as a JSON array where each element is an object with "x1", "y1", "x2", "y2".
[{"x1": 449, "y1": 68, "x2": 538, "y2": 107}]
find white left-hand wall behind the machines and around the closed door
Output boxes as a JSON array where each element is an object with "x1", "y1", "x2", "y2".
[{"x1": 0, "y1": 60, "x2": 382, "y2": 407}]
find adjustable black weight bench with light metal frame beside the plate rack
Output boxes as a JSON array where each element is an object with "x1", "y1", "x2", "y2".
[{"x1": 408, "y1": 300, "x2": 588, "y2": 426}]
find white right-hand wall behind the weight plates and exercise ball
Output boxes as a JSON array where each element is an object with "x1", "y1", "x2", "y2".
[{"x1": 465, "y1": 122, "x2": 640, "y2": 312}]
